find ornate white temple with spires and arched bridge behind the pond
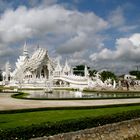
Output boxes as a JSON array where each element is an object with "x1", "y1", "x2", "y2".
[{"x1": 3, "y1": 43, "x2": 116, "y2": 89}]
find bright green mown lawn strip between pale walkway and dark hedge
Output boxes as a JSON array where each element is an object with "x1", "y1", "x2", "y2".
[{"x1": 0, "y1": 105, "x2": 140, "y2": 129}]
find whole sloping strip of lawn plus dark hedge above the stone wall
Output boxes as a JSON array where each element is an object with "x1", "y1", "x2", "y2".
[{"x1": 0, "y1": 105, "x2": 140, "y2": 140}]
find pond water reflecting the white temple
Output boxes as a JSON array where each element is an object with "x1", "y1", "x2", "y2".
[{"x1": 24, "y1": 90, "x2": 140, "y2": 99}]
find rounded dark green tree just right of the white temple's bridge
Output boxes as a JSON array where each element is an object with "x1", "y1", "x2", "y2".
[{"x1": 100, "y1": 71, "x2": 116, "y2": 82}]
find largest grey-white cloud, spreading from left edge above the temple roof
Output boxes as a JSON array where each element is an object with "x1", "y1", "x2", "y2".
[{"x1": 0, "y1": 3, "x2": 108, "y2": 68}]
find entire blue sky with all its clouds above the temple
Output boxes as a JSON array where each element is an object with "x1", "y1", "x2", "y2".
[{"x1": 0, "y1": 0, "x2": 140, "y2": 73}]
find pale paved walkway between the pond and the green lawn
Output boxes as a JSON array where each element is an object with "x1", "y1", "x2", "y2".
[{"x1": 0, "y1": 93, "x2": 140, "y2": 110}]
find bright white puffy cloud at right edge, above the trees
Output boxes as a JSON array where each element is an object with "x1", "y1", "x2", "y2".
[{"x1": 90, "y1": 33, "x2": 140, "y2": 72}]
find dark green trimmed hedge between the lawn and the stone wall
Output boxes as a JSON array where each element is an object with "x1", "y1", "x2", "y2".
[{"x1": 0, "y1": 110, "x2": 140, "y2": 140}]
